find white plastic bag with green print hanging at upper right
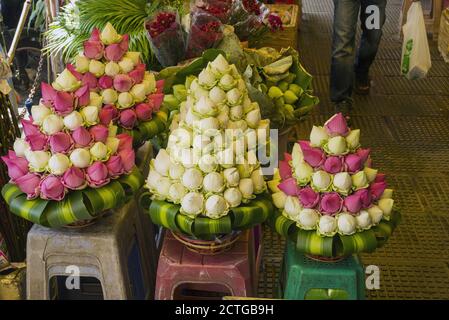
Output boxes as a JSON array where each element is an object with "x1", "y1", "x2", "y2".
[{"x1": 401, "y1": 1, "x2": 432, "y2": 80}]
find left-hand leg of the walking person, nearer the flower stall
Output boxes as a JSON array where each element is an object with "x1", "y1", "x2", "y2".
[{"x1": 330, "y1": 0, "x2": 360, "y2": 103}]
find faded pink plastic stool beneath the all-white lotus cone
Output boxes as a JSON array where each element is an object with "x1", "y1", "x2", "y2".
[{"x1": 155, "y1": 230, "x2": 256, "y2": 300}]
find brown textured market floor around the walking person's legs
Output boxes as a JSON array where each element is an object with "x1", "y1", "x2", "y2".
[{"x1": 259, "y1": 0, "x2": 449, "y2": 299}]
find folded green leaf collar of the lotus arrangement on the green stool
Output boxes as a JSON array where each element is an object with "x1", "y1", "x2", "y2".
[{"x1": 268, "y1": 210, "x2": 401, "y2": 257}]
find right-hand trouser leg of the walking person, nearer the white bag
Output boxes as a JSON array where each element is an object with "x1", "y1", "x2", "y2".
[{"x1": 354, "y1": 0, "x2": 387, "y2": 87}]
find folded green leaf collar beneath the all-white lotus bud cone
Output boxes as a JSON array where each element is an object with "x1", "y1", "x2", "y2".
[{"x1": 144, "y1": 192, "x2": 273, "y2": 239}]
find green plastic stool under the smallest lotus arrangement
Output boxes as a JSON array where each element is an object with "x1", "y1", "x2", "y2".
[{"x1": 277, "y1": 241, "x2": 365, "y2": 300}]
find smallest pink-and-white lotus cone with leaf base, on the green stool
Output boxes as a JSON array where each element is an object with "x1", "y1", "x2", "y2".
[{"x1": 269, "y1": 113, "x2": 400, "y2": 257}]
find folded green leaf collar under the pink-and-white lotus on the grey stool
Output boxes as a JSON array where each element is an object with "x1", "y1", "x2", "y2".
[{"x1": 2, "y1": 167, "x2": 144, "y2": 228}]
